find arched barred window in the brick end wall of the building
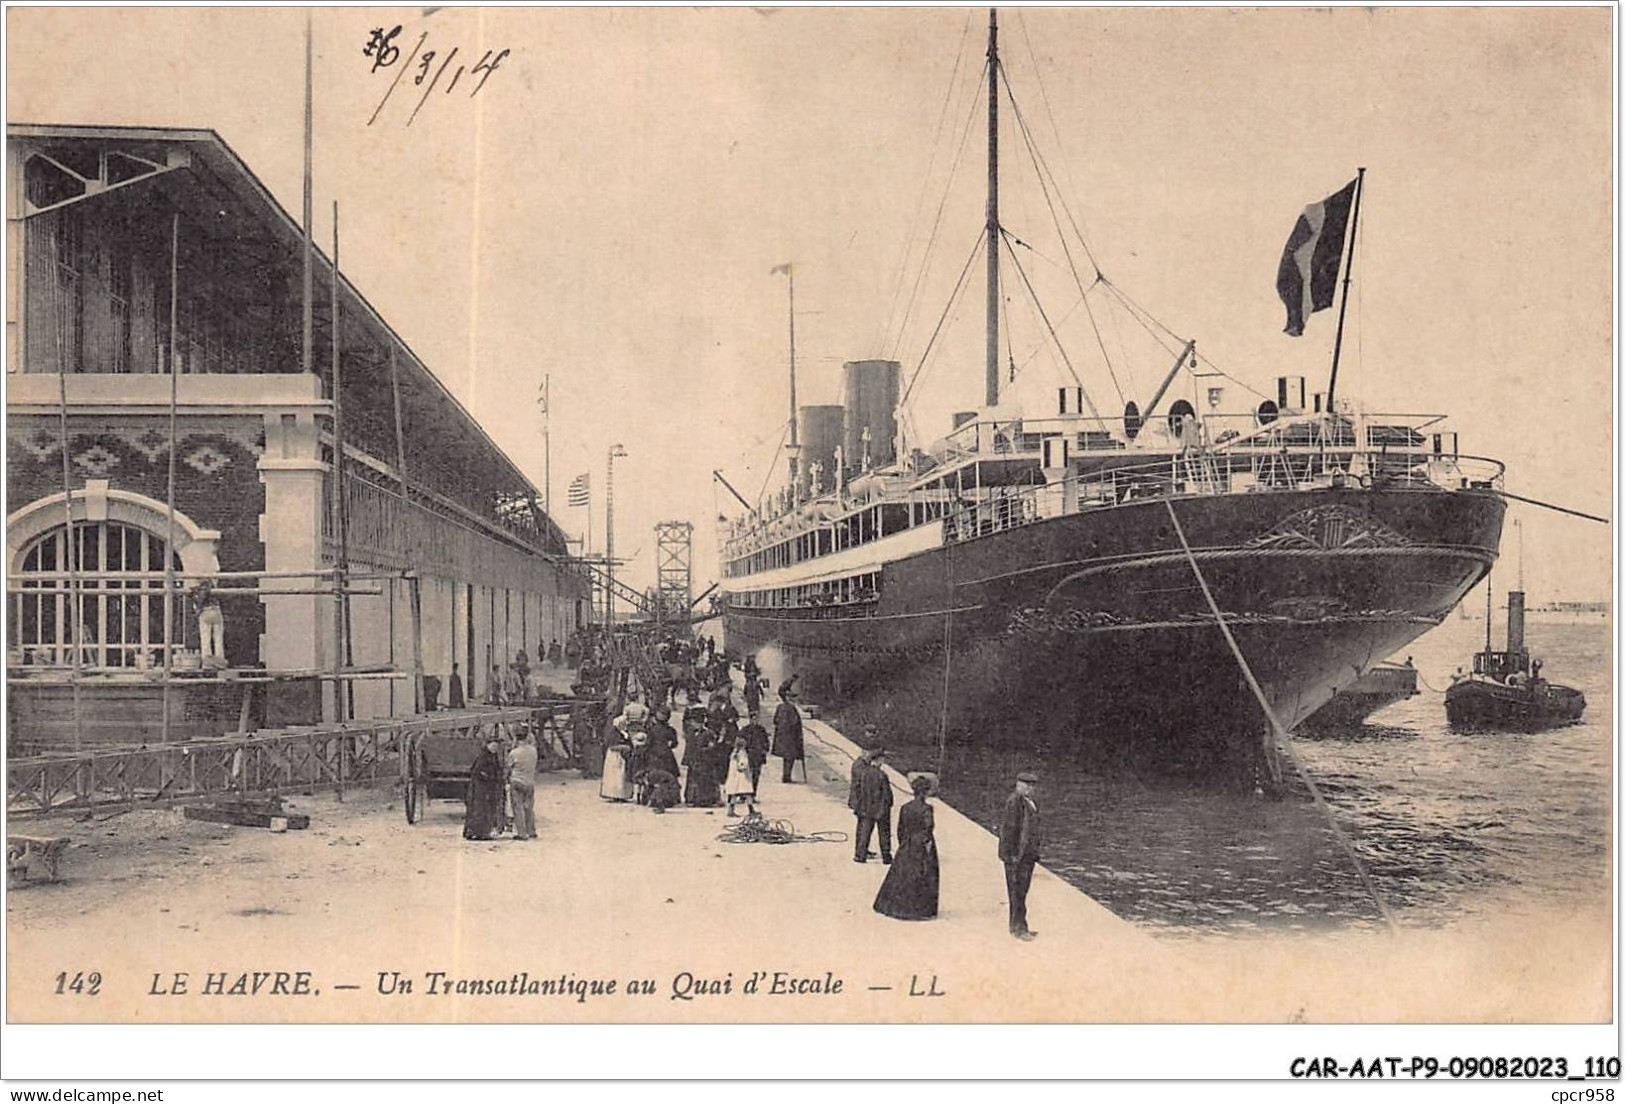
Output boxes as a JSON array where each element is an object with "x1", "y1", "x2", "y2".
[{"x1": 8, "y1": 522, "x2": 185, "y2": 668}]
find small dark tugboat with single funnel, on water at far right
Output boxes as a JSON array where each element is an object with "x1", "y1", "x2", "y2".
[{"x1": 1445, "y1": 578, "x2": 1586, "y2": 732}]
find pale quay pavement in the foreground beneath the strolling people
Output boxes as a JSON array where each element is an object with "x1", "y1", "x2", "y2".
[{"x1": 7, "y1": 686, "x2": 1609, "y2": 1023}]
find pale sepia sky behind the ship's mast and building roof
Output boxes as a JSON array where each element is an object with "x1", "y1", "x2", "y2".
[{"x1": 7, "y1": 8, "x2": 1614, "y2": 603}]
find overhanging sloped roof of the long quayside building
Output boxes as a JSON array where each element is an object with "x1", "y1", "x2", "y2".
[{"x1": 7, "y1": 124, "x2": 566, "y2": 551}]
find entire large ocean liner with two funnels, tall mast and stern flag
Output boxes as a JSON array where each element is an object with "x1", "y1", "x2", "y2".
[{"x1": 720, "y1": 13, "x2": 1505, "y2": 784}]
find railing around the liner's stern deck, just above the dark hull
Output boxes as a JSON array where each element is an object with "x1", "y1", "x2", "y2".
[{"x1": 943, "y1": 450, "x2": 1505, "y2": 541}]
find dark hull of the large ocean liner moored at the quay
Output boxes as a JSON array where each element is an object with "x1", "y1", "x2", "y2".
[{"x1": 725, "y1": 489, "x2": 1505, "y2": 774}]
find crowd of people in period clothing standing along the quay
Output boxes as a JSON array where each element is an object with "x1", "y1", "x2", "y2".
[{"x1": 463, "y1": 641, "x2": 1042, "y2": 940}]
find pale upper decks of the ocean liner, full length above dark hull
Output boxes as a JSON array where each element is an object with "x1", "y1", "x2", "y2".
[{"x1": 723, "y1": 413, "x2": 1503, "y2": 590}]
